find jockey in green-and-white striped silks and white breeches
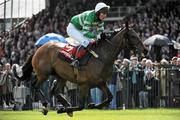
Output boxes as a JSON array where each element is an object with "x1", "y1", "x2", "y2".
[{"x1": 67, "y1": 2, "x2": 110, "y2": 65}]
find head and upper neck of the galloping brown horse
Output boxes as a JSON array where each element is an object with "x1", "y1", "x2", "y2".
[{"x1": 96, "y1": 25, "x2": 147, "y2": 61}]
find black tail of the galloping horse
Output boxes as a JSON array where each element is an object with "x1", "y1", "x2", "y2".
[{"x1": 12, "y1": 54, "x2": 34, "y2": 81}]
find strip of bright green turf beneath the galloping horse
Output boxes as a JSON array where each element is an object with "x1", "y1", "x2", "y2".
[{"x1": 0, "y1": 109, "x2": 180, "y2": 120}]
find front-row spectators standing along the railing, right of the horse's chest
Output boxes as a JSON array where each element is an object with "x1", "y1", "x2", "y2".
[{"x1": 116, "y1": 56, "x2": 180, "y2": 108}]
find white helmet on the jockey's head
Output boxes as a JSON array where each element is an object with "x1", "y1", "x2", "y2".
[{"x1": 95, "y1": 2, "x2": 110, "y2": 14}]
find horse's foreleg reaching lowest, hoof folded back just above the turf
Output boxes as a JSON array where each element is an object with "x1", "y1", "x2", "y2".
[{"x1": 58, "y1": 85, "x2": 89, "y2": 113}]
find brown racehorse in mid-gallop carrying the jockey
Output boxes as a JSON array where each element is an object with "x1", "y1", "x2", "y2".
[{"x1": 32, "y1": 25, "x2": 146, "y2": 115}]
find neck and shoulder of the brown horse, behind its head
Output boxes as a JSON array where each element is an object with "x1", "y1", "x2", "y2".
[{"x1": 88, "y1": 32, "x2": 122, "y2": 79}]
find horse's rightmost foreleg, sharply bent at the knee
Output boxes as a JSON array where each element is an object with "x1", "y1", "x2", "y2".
[{"x1": 88, "y1": 83, "x2": 113, "y2": 109}]
